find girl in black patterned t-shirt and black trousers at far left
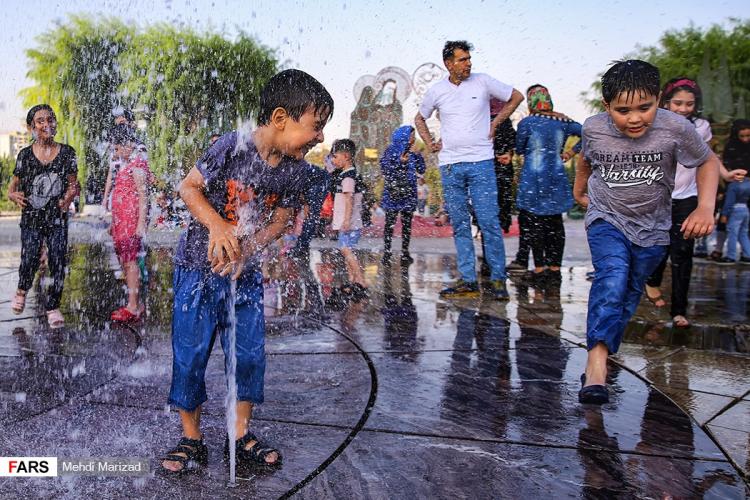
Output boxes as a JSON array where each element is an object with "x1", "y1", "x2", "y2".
[{"x1": 8, "y1": 104, "x2": 79, "y2": 328}]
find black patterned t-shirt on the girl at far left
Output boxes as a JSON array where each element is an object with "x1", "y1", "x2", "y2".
[{"x1": 13, "y1": 144, "x2": 78, "y2": 229}]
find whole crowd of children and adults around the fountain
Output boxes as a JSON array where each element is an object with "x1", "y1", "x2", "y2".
[{"x1": 10, "y1": 41, "x2": 750, "y2": 473}]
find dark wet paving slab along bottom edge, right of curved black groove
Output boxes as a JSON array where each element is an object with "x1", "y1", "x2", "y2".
[{"x1": 300, "y1": 428, "x2": 745, "y2": 498}]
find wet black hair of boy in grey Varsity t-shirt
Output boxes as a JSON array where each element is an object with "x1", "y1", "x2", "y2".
[{"x1": 602, "y1": 59, "x2": 660, "y2": 103}]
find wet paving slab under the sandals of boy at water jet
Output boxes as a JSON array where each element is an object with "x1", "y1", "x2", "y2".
[{"x1": 0, "y1": 404, "x2": 349, "y2": 498}]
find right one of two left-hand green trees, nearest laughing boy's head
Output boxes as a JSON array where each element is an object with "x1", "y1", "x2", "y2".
[{"x1": 120, "y1": 24, "x2": 278, "y2": 182}]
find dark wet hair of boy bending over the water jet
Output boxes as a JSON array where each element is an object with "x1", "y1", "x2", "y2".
[{"x1": 258, "y1": 69, "x2": 333, "y2": 125}]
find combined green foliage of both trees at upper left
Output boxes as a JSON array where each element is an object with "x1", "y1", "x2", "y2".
[{"x1": 22, "y1": 16, "x2": 279, "y2": 195}]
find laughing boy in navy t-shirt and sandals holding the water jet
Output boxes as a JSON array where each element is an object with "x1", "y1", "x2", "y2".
[{"x1": 162, "y1": 70, "x2": 333, "y2": 472}]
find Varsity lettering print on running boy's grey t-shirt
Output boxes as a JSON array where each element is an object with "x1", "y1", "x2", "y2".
[{"x1": 592, "y1": 151, "x2": 664, "y2": 188}]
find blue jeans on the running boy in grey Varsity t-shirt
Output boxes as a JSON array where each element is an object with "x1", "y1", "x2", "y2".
[{"x1": 586, "y1": 219, "x2": 667, "y2": 353}]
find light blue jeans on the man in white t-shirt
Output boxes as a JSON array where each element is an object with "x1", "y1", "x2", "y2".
[{"x1": 440, "y1": 160, "x2": 506, "y2": 282}]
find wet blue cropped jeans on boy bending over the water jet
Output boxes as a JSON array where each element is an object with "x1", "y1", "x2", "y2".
[{"x1": 169, "y1": 266, "x2": 266, "y2": 411}]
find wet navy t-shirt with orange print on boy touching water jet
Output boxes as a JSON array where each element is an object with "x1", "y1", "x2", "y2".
[{"x1": 175, "y1": 132, "x2": 307, "y2": 270}]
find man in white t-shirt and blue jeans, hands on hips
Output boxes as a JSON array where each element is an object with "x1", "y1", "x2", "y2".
[{"x1": 414, "y1": 41, "x2": 523, "y2": 300}]
